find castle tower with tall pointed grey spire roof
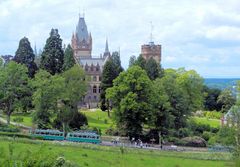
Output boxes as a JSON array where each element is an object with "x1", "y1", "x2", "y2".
[{"x1": 72, "y1": 16, "x2": 92, "y2": 60}]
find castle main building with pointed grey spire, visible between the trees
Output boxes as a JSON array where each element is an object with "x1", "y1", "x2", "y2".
[{"x1": 71, "y1": 16, "x2": 111, "y2": 108}]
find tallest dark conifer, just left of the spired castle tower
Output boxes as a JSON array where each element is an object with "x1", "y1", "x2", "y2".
[{"x1": 40, "y1": 29, "x2": 64, "y2": 75}]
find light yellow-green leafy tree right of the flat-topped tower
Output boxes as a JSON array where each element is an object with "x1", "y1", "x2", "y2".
[{"x1": 161, "y1": 68, "x2": 203, "y2": 129}]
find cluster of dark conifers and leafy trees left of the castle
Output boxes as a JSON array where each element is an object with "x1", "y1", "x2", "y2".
[{"x1": 0, "y1": 29, "x2": 87, "y2": 134}]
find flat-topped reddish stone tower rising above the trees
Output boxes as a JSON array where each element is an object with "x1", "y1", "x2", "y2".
[{"x1": 141, "y1": 42, "x2": 162, "y2": 63}]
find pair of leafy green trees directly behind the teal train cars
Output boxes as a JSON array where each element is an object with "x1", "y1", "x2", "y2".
[{"x1": 32, "y1": 65, "x2": 86, "y2": 131}]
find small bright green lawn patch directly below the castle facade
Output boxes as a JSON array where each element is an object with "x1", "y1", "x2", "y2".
[{"x1": 81, "y1": 109, "x2": 113, "y2": 135}]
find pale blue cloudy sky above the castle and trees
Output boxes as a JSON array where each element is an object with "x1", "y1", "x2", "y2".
[{"x1": 0, "y1": 0, "x2": 240, "y2": 78}]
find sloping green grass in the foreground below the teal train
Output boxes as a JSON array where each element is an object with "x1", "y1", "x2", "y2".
[{"x1": 0, "y1": 138, "x2": 231, "y2": 167}]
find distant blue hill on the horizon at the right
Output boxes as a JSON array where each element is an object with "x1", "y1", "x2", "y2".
[{"x1": 204, "y1": 78, "x2": 240, "y2": 90}]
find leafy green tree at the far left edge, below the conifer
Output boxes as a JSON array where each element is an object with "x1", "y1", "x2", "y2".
[{"x1": 0, "y1": 61, "x2": 29, "y2": 124}]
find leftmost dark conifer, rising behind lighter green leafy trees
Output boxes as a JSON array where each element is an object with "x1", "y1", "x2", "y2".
[{"x1": 13, "y1": 37, "x2": 37, "y2": 78}]
